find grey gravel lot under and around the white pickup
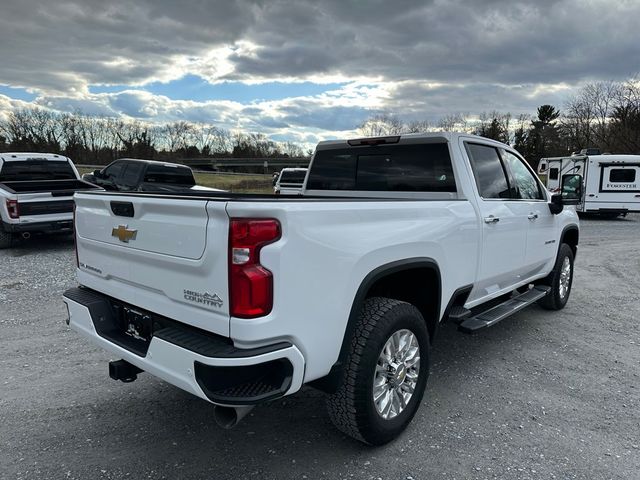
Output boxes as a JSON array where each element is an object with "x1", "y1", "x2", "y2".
[{"x1": 0, "y1": 215, "x2": 640, "y2": 480}]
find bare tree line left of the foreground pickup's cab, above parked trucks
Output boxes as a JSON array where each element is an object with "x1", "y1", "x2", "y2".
[{"x1": 0, "y1": 108, "x2": 305, "y2": 165}]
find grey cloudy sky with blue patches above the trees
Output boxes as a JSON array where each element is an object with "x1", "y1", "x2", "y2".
[{"x1": 0, "y1": 0, "x2": 640, "y2": 143}]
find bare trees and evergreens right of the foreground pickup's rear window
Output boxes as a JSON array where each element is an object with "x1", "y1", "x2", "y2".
[{"x1": 358, "y1": 78, "x2": 640, "y2": 168}]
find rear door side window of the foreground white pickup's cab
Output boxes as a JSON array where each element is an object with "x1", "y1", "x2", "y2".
[{"x1": 465, "y1": 143, "x2": 511, "y2": 199}]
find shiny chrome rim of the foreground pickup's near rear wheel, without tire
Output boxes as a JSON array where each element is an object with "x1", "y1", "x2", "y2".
[{"x1": 373, "y1": 329, "x2": 420, "y2": 420}]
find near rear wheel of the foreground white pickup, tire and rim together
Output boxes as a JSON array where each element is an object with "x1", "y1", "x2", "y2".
[{"x1": 327, "y1": 297, "x2": 429, "y2": 445}]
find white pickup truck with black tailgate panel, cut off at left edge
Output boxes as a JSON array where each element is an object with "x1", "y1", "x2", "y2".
[{"x1": 0, "y1": 153, "x2": 96, "y2": 248}]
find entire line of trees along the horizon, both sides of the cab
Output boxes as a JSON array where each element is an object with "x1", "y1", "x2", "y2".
[{"x1": 0, "y1": 78, "x2": 640, "y2": 167}]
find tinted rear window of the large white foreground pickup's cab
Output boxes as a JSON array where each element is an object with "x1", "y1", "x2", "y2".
[{"x1": 307, "y1": 143, "x2": 456, "y2": 192}]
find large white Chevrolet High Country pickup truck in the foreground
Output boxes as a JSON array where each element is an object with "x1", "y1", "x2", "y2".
[{"x1": 64, "y1": 133, "x2": 580, "y2": 444}]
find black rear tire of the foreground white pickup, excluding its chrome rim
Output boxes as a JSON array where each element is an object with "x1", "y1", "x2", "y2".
[{"x1": 327, "y1": 297, "x2": 430, "y2": 445}]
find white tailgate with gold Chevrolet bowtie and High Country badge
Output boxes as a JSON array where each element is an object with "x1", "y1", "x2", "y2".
[{"x1": 75, "y1": 193, "x2": 229, "y2": 336}]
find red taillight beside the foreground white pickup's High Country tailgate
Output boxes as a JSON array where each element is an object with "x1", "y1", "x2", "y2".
[{"x1": 229, "y1": 218, "x2": 281, "y2": 318}]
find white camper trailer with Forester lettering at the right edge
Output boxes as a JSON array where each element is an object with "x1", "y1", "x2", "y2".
[{"x1": 538, "y1": 155, "x2": 640, "y2": 217}]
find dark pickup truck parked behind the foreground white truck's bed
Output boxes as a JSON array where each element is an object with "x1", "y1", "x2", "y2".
[{"x1": 82, "y1": 158, "x2": 219, "y2": 192}]
